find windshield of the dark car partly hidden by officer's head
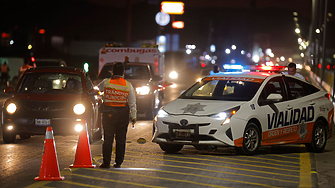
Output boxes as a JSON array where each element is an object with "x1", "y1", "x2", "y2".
[{"x1": 98, "y1": 64, "x2": 150, "y2": 80}]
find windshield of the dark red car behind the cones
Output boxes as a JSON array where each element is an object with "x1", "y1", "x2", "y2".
[{"x1": 17, "y1": 72, "x2": 83, "y2": 94}]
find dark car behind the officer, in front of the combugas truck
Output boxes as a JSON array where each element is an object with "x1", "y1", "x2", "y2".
[{"x1": 95, "y1": 63, "x2": 164, "y2": 119}]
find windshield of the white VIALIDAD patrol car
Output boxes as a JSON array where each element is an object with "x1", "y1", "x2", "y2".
[{"x1": 179, "y1": 80, "x2": 261, "y2": 101}]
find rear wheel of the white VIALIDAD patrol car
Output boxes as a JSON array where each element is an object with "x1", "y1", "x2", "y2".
[{"x1": 305, "y1": 120, "x2": 327, "y2": 153}]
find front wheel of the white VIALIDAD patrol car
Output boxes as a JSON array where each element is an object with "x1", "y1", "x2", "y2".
[{"x1": 241, "y1": 122, "x2": 261, "y2": 155}]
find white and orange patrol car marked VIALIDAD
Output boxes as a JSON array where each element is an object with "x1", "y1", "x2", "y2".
[{"x1": 152, "y1": 72, "x2": 334, "y2": 155}]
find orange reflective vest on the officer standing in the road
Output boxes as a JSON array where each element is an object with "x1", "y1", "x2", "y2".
[{"x1": 104, "y1": 77, "x2": 130, "y2": 107}]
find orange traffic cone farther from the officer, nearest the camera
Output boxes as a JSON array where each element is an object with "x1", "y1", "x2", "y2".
[{"x1": 35, "y1": 127, "x2": 64, "y2": 181}]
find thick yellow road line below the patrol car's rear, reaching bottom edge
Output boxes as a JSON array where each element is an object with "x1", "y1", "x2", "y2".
[{"x1": 299, "y1": 153, "x2": 312, "y2": 188}]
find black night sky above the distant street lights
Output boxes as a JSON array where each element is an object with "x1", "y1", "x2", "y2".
[{"x1": 0, "y1": 0, "x2": 335, "y2": 68}]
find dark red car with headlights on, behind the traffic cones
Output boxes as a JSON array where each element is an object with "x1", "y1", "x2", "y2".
[{"x1": 2, "y1": 67, "x2": 102, "y2": 143}]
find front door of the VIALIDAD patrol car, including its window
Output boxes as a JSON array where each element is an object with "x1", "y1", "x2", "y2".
[{"x1": 258, "y1": 75, "x2": 297, "y2": 145}]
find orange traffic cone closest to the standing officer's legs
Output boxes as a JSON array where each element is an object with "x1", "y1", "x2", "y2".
[{"x1": 70, "y1": 128, "x2": 95, "y2": 168}]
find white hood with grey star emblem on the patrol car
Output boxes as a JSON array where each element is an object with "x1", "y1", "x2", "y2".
[{"x1": 164, "y1": 99, "x2": 245, "y2": 116}]
